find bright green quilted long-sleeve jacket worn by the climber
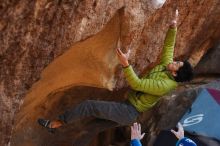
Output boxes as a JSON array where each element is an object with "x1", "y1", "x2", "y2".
[{"x1": 124, "y1": 28, "x2": 177, "y2": 112}]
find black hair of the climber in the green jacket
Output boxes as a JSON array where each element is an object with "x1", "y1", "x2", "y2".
[{"x1": 174, "y1": 61, "x2": 193, "y2": 82}]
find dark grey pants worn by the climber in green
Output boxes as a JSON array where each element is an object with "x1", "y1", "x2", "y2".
[{"x1": 59, "y1": 100, "x2": 139, "y2": 125}]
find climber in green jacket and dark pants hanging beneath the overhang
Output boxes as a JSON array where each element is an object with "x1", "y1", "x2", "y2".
[{"x1": 38, "y1": 10, "x2": 193, "y2": 131}]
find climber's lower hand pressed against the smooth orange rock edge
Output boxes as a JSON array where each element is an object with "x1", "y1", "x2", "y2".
[{"x1": 116, "y1": 40, "x2": 130, "y2": 67}]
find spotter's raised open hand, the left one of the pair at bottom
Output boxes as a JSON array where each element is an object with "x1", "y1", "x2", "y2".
[{"x1": 131, "y1": 123, "x2": 145, "y2": 140}]
